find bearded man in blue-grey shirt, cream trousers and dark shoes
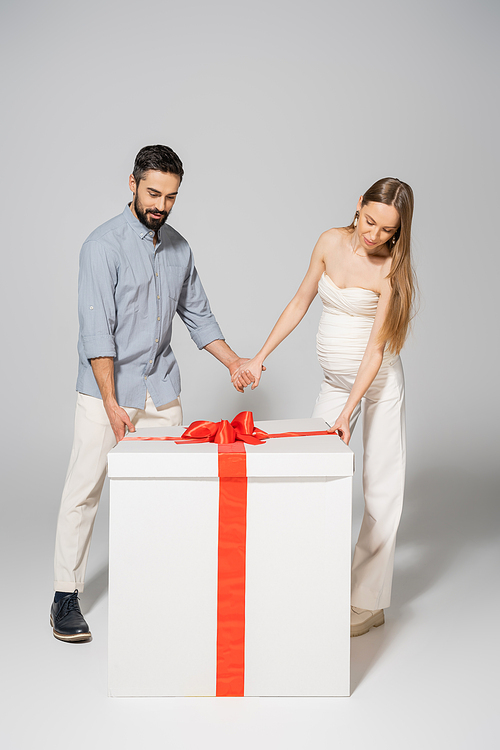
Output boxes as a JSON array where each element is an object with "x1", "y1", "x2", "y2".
[{"x1": 51, "y1": 146, "x2": 250, "y2": 642}]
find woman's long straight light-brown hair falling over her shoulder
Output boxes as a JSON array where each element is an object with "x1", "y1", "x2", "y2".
[{"x1": 347, "y1": 177, "x2": 416, "y2": 354}]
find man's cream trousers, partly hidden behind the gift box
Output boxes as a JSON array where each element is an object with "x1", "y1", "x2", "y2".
[{"x1": 54, "y1": 393, "x2": 182, "y2": 591}]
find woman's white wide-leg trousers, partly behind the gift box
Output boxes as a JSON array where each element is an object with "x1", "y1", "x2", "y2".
[{"x1": 313, "y1": 357, "x2": 406, "y2": 610}]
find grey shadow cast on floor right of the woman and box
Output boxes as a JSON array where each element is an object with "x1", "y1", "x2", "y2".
[{"x1": 351, "y1": 466, "x2": 500, "y2": 693}]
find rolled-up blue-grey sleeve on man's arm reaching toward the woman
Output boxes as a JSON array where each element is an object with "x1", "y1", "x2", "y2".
[{"x1": 177, "y1": 254, "x2": 224, "y2": 349}]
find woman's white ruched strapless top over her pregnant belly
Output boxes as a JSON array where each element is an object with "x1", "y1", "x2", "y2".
[{"x1": 316, "y1": 273, "x2": 394, "y2": 375}]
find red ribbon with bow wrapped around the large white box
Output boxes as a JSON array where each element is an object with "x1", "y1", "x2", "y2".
[{"x1": 119, "y1": 411, "x2": 336, "y2": 696}]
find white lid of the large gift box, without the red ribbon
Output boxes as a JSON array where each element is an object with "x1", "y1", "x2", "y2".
[{"x1": 108, "y1": 419, "x2": 354, "y2": 479}]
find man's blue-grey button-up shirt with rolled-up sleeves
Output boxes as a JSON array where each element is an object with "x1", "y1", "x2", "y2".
[{"x1": 76, "y1": 206, "x2": 224, "y2": 409}]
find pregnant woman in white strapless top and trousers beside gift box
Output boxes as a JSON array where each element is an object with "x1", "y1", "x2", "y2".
[{"x1": 232, "y1": 177, "x2": 414, "y2": 636}]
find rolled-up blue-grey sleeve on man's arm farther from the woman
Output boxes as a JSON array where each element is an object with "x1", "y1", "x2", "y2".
[{"x1": 78, "y1": 241, "x2": 118, "y2": 359}]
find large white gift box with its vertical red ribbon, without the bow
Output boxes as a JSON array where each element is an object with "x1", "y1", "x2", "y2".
[{"x1": 108, "y1": 419, "x2": 354, "y2": 696}]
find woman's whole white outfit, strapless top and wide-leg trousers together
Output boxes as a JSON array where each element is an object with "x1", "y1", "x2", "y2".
[{"x1": 313, "y1": 274, "x2": 406, "y2": 610}]
